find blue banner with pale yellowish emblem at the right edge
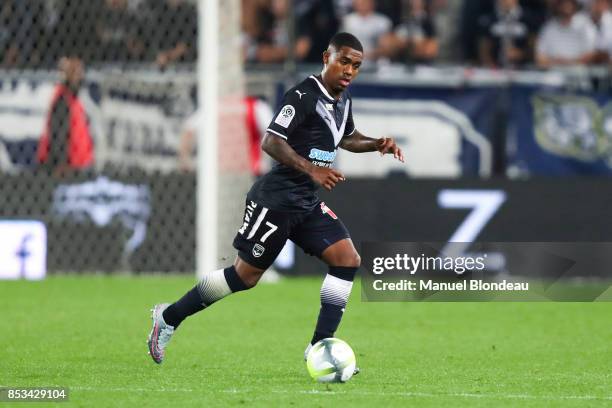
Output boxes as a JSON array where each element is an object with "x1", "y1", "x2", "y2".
[{"x1": 507, "y1": 85, "x2": 612, "y2": 176}]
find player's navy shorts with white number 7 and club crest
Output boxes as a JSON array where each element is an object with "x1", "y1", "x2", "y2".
[{"x1": 234, "y1": 200, "x2": 350, "y2": 269}]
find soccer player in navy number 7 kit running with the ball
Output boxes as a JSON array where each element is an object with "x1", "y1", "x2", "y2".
[{"x1": 148, "y1": 33, "x2": 404, "y2": 363}]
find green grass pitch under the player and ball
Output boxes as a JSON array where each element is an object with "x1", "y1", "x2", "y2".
[{"x1": 0, "y1": 276, "x2": 612, "y2": 407}]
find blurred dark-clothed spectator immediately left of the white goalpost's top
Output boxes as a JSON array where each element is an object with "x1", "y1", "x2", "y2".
[{"x1": 141, "y1": 0, "x2": 198, "y2": 68}]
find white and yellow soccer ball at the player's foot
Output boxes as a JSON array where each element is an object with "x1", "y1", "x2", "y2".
[{"x1": 306, "y1": 337, "x2": 356, "y2": 383}]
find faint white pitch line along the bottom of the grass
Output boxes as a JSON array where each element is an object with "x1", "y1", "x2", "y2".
[{"x1": 64, "y1": 387, "x2": 612, "y2": 401}]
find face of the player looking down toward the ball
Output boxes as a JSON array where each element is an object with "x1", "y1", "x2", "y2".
[{"x1": 323, "y1": 47, "x2": 363, "y2": 95}]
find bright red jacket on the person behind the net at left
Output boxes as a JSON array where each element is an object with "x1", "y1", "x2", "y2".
[{"x1": 37, "y1": 84, "x2": 94, "y2": 169}]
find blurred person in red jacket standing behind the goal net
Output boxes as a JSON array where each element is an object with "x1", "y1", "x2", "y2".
[{"x1": 37, "y1": 57, "x2": 94, "y2": 175}]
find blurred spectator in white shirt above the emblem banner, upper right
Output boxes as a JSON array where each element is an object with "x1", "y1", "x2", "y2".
[{"x1": 536, "y1": 0, "x2": 596, "y2": 68}]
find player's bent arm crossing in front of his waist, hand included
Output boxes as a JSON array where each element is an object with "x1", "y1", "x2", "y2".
[{"x1": 261, "y1": 133, "x2": 345, "y2": 191}]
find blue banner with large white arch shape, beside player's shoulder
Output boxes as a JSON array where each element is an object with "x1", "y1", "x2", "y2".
[{"x1": 351, "y1": 83, "x2": 499, "y2": 177}]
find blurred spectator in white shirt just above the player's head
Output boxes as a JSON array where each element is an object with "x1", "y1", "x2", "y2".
[{"x1": 341, "y1": 0, "x2": 392, "y2": 62}]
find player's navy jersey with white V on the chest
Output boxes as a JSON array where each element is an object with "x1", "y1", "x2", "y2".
[{"x1": 248, "y1": 76, "x2": 355, "y2": 212}]
